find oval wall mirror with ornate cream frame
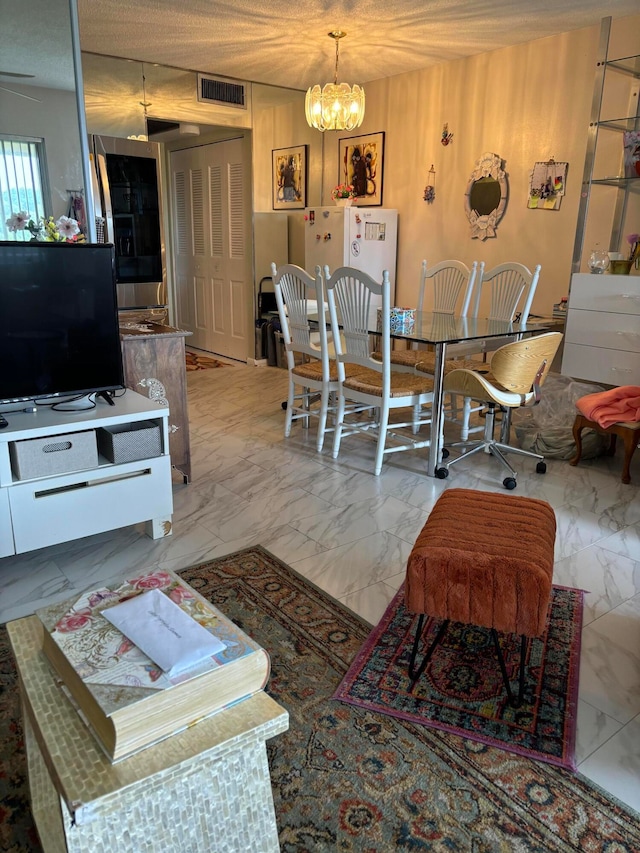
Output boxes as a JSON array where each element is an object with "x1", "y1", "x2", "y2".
[{"x1": 464, "y1": 152, "x2": 508, "y2": 240}]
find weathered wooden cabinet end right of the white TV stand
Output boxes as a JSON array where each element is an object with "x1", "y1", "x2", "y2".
[{"x1": 120, "y1": 323, "x2": 191, "y2": 483}]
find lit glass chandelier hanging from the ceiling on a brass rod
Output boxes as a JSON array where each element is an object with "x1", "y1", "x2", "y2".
[{"x1": 304, "y1": 30, "x2": 364, "y2": 131}]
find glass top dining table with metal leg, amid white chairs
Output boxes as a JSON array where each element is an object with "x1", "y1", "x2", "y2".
[{"x1": 376, "y1": 311, "x2": 555, "y2": 477}]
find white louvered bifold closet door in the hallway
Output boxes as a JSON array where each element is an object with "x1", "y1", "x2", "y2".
[{"x1": 171, "y1": 140, "x2": 250, "y2": 361}]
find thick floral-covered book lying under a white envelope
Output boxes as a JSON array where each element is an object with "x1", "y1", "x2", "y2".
[{"x1": 36, "y1": 570, "x2": 270, "y2": 762}]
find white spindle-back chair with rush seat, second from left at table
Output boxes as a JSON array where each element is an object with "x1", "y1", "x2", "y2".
[{"x1": 324, "y1": 266, "x2": 433, "y2": 476}]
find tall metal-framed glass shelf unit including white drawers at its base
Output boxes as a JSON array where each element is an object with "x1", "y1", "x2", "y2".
[{"x1": 562, "y1": 18, "x2": 640, "y2": 386}]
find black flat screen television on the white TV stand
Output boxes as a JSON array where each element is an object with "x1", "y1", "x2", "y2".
[{"x1": 0, "y1": 241, "x2": 124, "y2": 412}]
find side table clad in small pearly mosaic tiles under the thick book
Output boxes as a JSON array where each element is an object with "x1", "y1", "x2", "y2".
[{"x1": 7, "y1": 616, "x2": 289, "y2": 853}]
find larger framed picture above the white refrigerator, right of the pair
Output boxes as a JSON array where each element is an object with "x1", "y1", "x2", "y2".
[{"x1": 338, "y1": 131, "x2": 384, "y2": 206}]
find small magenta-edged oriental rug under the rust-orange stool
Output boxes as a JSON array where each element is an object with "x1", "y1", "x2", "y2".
[{"x1": 334, "y1": 587, "x2": 583, "y2": 769}]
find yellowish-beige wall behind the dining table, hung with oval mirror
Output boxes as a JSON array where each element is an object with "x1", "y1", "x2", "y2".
[{"x1": 253, "y1": 16, "x2": 640, "y2": 314}]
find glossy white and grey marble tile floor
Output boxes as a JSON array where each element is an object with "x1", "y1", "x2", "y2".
[{"x1": 0, "y1": 364, "x2": 640, "y2": 811}]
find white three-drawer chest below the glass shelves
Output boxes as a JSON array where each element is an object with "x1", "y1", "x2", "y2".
[{"x1": 562, "y1": 273, "x2": 640, "y2": 385}]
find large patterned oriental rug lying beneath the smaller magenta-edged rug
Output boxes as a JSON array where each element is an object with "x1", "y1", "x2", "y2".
[{"x1": 0, "y1": 547, "x2": 640, "y2": 853}]
